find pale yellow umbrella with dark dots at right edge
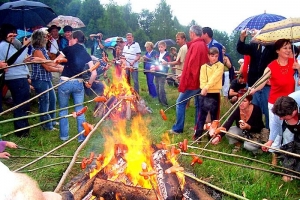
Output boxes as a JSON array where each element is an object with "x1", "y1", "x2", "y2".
[{"x1": 251, "y1": 18, "x2": 300, "y2": 45}]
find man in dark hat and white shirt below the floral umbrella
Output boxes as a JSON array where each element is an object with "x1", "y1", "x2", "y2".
[{"x1": 47, "y1": 25, "x2": 67, "y2": 60}]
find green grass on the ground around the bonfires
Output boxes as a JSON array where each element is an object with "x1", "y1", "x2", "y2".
[{"x1": 0, "y1": 67, "x2": 300, "y2": 200}]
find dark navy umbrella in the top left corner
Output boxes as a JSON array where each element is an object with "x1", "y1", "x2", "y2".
[{"x1": 0, "y1": 0, "x2": 57, "y2": 29}]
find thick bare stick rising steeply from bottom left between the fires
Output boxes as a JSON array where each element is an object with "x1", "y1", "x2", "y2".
[{"x1": 54, "y1": 99, "x2": 124, "y2": 192}]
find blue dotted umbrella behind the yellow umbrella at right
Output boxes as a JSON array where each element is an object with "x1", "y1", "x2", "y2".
[{"x1": 234, "y1": 12, "x2": 285, "y2": 31}]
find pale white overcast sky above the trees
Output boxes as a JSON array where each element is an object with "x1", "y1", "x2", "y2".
[{"x1": 100, "y1": 0, "x2": 300, "y2": 34}]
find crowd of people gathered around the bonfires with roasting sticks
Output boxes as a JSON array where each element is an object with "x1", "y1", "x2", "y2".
[{"x1": 0, "y1": 20, "x2": 300, "y2": 197}]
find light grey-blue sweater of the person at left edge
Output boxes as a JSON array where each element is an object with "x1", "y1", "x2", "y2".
[{"x1": 0, "y1": 41, "x2": 29, "y2": 80}]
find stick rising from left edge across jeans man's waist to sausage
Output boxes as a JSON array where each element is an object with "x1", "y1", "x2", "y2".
[{"x1": 0, "y1": 62, "x2": 100, "y2": 116}]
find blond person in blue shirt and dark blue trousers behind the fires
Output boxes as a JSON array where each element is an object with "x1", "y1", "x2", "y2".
[{"x1": 143, "y1": 42, "x2": 158, "y2": 98}]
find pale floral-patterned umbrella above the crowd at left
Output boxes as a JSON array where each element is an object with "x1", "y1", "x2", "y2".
[{"x1": 48, "y1": 15, "x2": 85, "y2": 28}]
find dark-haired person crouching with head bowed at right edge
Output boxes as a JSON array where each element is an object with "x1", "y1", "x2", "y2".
[{"x1": 272, "y1": 91, "x2": 300, "y2": 182}]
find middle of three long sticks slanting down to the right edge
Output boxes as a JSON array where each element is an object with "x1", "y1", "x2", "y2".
[{"x1": 188, "y1": 145, "x2": 300, "y2": 175}]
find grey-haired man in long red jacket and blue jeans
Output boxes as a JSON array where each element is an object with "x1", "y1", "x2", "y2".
[{"x1": 169, "y1": 25, "x2": 208, "y2": 134}]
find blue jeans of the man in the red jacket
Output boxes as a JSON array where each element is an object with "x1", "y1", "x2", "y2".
[{"x1": 172, "y1": 89, "x2": 200, "y2": 133}]
